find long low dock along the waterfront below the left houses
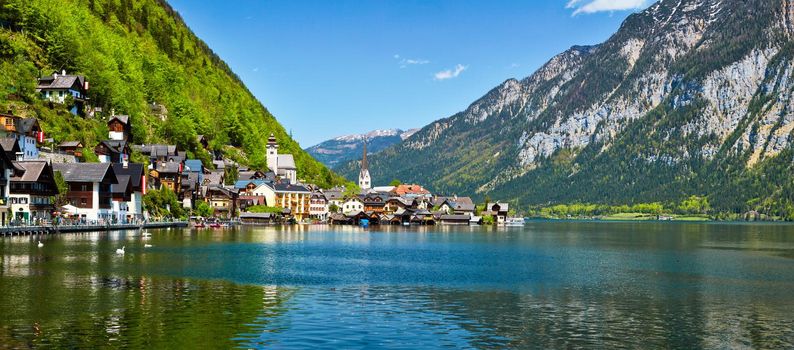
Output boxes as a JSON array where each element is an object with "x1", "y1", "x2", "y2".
[{"x1": 0, "y1": 221, "x2": 188, "y2": 237}]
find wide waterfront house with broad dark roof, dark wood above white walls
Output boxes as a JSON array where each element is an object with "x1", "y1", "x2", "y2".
[{"x1": 52, "y1": 163, "x2": 118, "y2": 221}]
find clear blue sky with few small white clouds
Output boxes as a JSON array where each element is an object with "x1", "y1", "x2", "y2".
[{"x1": 169, "y1": 0, "x2": 649, "y2": 147}]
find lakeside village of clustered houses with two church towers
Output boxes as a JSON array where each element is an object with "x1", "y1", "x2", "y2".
[{"x1": 0, "y1": 71, "x2": 523, "y2": 227}]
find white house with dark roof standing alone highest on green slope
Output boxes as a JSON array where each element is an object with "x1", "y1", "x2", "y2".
[{"x1": 36, "y1": 71, "x2": 88, "y2": 115}]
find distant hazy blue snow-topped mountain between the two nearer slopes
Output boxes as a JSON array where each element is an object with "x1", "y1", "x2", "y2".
[{"x1": 306, "y1": 129, "x2": 419, "y2": 168}]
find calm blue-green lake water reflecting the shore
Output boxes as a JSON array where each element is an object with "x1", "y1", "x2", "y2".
[{"x1": 0, "y1": 222, "x2": 794, "y2": 349}]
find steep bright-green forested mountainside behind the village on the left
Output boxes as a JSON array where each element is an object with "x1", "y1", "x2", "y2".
[{"x1": 0, "y1": 0, "x2": 344, "y2": 186}]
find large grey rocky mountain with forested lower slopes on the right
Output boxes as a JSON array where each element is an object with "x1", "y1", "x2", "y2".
[{"x1": 338, "y1": 0, "x2": 794, "y2": 218}]
